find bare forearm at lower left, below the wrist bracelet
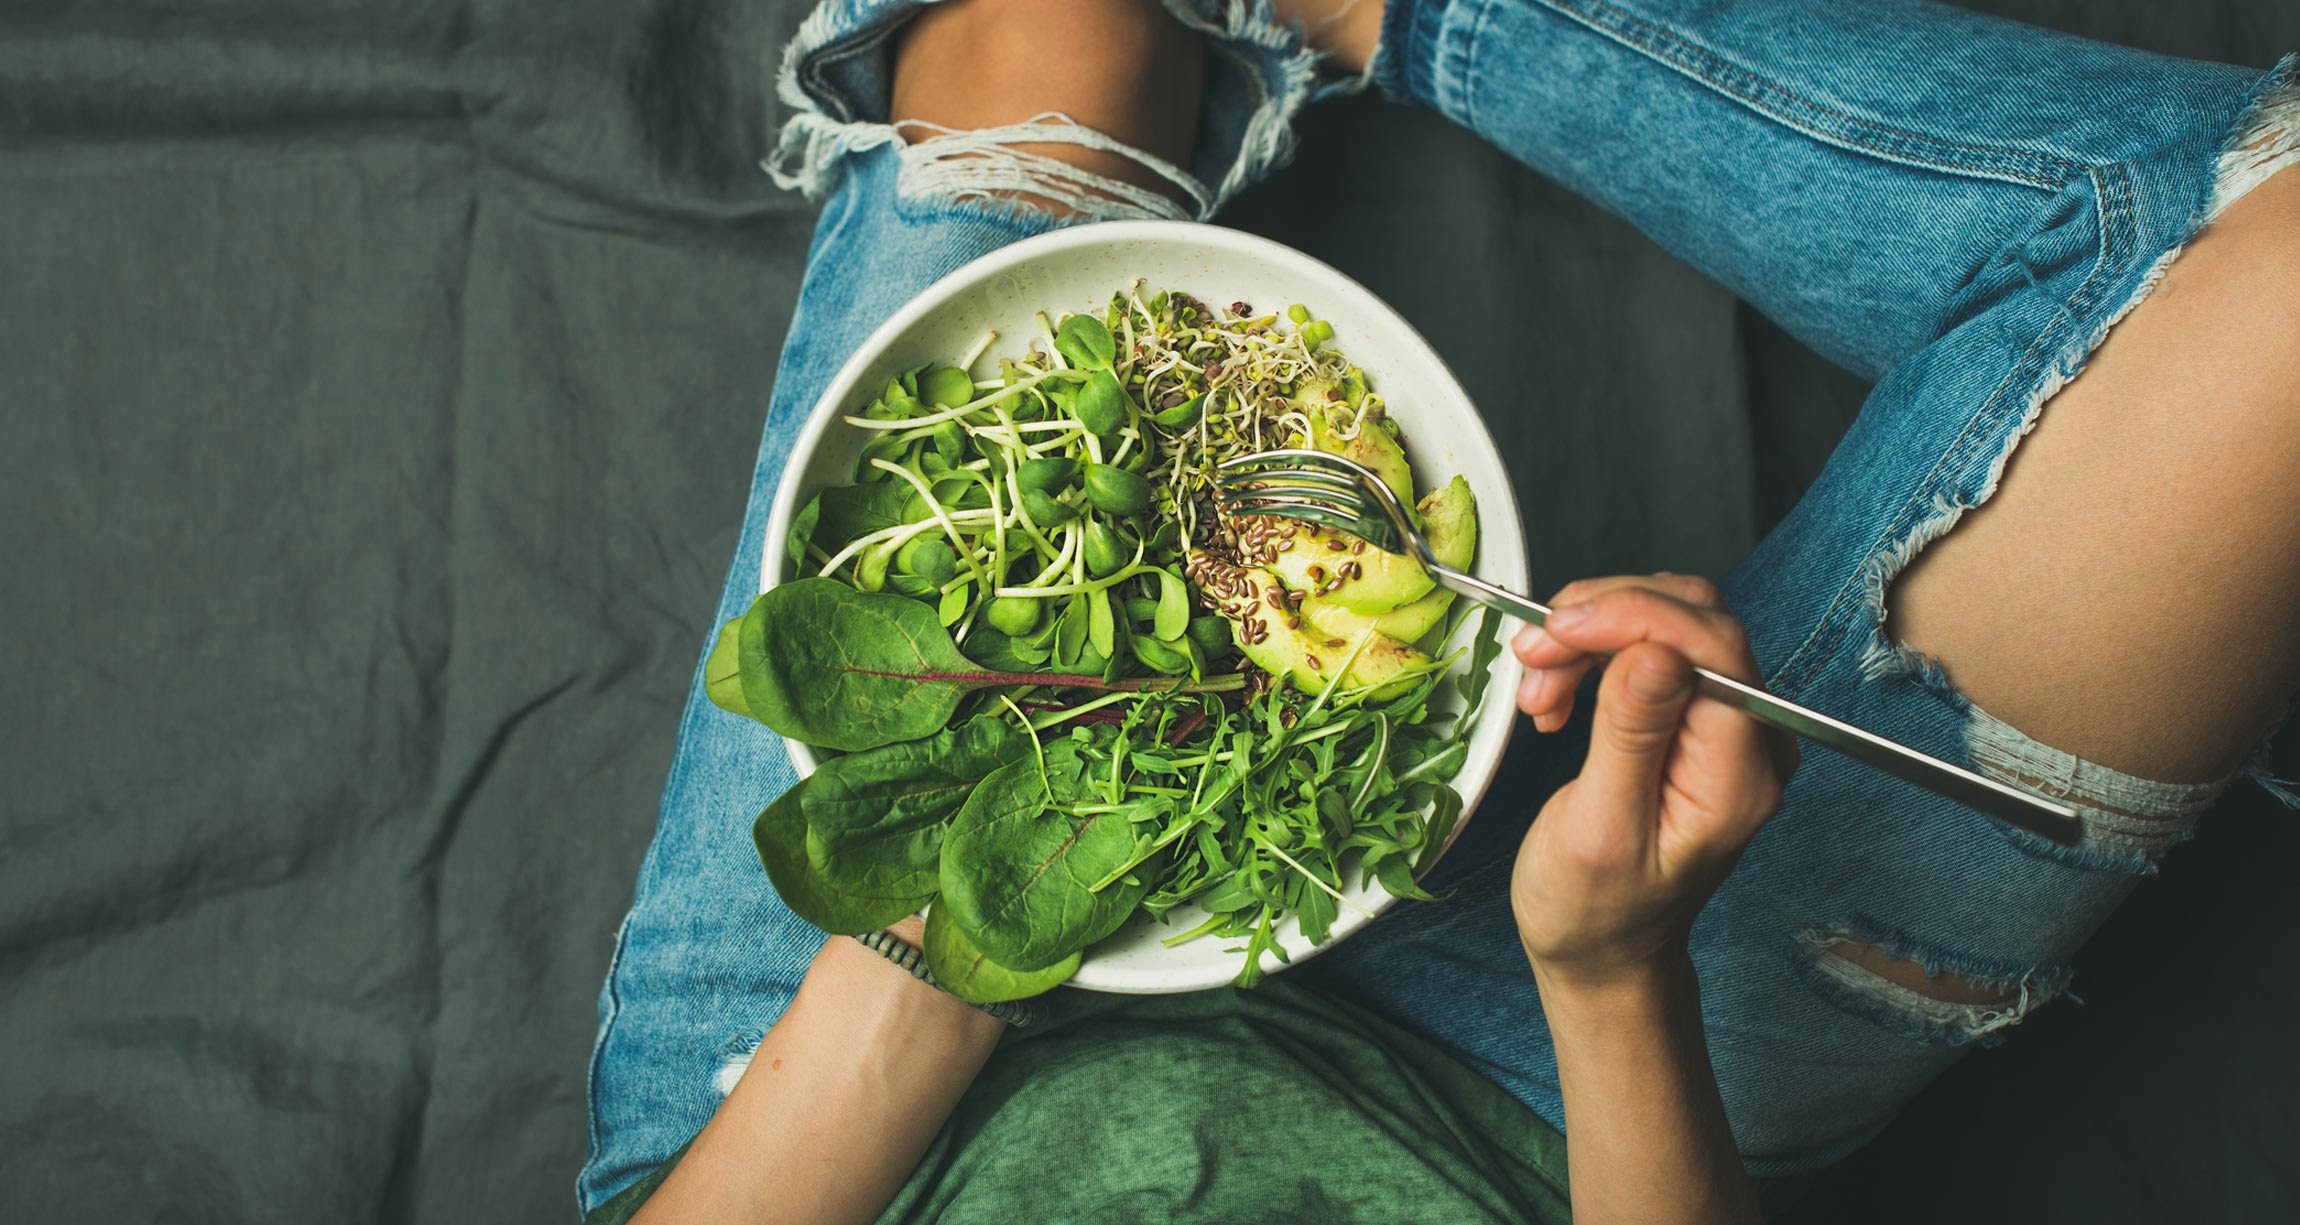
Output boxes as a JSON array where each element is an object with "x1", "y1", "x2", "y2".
[{"x1": 635, "y1": 938, "x2": 1005, "y2": 1225}]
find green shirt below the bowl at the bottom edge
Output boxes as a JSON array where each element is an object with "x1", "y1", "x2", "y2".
[{"x1": 587, "y1": 979, "x2": 1571, "y2": 1225}]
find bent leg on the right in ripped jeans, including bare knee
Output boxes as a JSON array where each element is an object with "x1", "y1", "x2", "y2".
[{"x1": 1309, "y1": 0, "x2": 2300, "y2": 1172}]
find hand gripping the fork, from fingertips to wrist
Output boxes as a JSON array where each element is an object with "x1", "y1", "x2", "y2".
[{"x1": 1511, "y1": 575, "x2": 1796, "y2": 986}]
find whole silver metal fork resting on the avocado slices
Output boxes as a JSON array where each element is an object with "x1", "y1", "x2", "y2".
[{"x1": 1214, "y1": 450, "x2": 2084, "y2": 846}]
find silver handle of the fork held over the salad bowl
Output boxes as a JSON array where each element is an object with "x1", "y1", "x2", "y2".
[{"x1": 1424, "y1": 563, "x2": 2084, "y2": 846}]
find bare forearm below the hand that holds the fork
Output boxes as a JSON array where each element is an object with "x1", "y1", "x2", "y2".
[{"x1": 1534, "y1": 958, "x2": 1762, "y2": 1225}]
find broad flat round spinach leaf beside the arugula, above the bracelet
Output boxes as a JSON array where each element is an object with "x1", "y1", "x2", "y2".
[{"x1": 943, "y1": 742, "x2": 1155, "y2": 970}]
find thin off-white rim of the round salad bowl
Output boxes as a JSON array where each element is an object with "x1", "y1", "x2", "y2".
[{"x1": 759, "y1": 221, "x2": 1530, "y2": 995}]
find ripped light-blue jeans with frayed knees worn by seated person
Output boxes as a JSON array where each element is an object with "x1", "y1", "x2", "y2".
[{"x1": 580, "y1": 0, "x2": 2300, "y2": 1211}]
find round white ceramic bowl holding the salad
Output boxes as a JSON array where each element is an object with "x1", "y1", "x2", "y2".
[{"x1": 761, "y1": 221, "x2": 1527, "y2": 993}]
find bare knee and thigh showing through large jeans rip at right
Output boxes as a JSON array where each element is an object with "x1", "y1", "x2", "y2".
[{"x1": 1888, "y1": 159, "x2": 2300, "y2": 779}]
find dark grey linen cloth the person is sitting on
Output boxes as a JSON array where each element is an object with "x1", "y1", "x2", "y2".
[{"x1": 0, "y1": 0, "x2": 2300, "y2": 1223}]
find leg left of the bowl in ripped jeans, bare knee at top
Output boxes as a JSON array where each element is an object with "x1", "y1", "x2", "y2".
[{"x1": 577, "y1": 0, "x2": 1334, "y2": 1211}]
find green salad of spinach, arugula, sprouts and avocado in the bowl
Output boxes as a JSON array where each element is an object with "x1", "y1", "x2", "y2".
[{"x1": 708, "y1": 224, "x2": 1513, "y2": 1002}]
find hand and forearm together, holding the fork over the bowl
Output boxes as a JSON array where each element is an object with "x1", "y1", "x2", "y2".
[{"x1": 1511, "y1": 575, "x2": 1796, "y2": 1225}]
